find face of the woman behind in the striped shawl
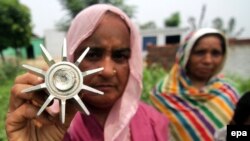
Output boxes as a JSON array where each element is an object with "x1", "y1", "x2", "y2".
[{"x1": 187, "y1": 35, "x2": 224, "y2": 81}]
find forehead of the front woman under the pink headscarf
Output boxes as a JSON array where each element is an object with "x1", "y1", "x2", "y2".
[{"x1": 75, "y1": 11, "x2": 130, "y2": 53}]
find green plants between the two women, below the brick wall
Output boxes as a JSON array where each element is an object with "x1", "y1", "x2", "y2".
[{"x1": 141, "y1": 65, "x2": 166, "y2": 103}]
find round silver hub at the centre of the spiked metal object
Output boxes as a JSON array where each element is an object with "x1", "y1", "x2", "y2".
[{"x1": 45, "y1": 62, "x2": 84, "y2": 99}]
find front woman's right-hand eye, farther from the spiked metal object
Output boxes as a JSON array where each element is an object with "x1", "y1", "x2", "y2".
[{"x1": 112, "y1": 48, "x2": 131, "y2": 63}]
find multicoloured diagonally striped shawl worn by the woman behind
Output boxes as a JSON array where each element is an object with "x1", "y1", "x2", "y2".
[{"x1": 150, "y1": 28, "x2": 239, "y2": 141}]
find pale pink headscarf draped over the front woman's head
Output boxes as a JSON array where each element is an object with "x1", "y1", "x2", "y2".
[{"x1": 67, "y1": 4, "x2": 142, "y2": 141}]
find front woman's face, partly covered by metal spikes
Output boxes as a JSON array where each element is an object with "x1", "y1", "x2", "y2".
[{"x1": 75, "y1": 13, "x2": 130, "y2": 109}]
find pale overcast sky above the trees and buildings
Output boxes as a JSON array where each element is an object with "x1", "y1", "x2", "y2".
[{"x1": 20, "y1": 0, "x2": 250, "y2": 38}]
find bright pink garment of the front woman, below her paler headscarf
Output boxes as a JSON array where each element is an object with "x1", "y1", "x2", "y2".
[{"x1": 63, "y1": 103, "x2": 169, "y2": 141}]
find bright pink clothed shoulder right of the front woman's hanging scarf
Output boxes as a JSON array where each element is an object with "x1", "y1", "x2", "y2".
[{"x1": 130, "y1": 102, "x2": 169, "y2": 141}]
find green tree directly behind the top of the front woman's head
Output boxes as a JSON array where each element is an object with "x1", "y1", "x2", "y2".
[{"x1": 57, "y1": 0, "x2": 135, "y2": 31}]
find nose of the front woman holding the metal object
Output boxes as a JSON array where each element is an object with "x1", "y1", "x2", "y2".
[{"x1": 101, "y1": 57, "x2": 116, "y2": 78}]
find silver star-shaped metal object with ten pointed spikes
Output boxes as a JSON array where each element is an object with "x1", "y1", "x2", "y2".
[{"x1": 22, "y1": 39, "x2": 103, "y2": 123}]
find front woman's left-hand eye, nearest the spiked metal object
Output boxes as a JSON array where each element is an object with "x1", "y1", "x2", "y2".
[{"x1": 85, "y1": 48, "x2": 104, "y2": 62}]
